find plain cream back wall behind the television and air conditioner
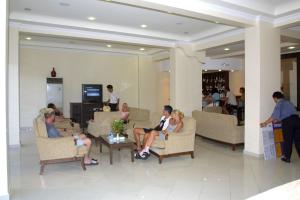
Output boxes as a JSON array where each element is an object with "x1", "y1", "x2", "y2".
[{"x1": 20, "y1": 47, "x2": 157, "y2": 127}]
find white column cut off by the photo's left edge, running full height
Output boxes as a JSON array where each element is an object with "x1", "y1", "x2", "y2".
[{"x1": 0, "y1": 1, "x2": 9, "y2": 200}]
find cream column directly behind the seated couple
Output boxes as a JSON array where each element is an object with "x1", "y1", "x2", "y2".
[{"x1": 170, "y1": 46, "x2": 204, "y2": 116}]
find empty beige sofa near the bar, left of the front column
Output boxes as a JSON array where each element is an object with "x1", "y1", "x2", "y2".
[{"x1": 192, "y1": 110, "x2": 244, "y2": 151}]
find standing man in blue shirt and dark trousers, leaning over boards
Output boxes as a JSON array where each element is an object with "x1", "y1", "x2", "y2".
[{"x1": 260, "y1": 91, "x2": 300, "y2": 163}]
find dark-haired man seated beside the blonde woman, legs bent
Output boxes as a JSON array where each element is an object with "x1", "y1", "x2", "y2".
[{"x1": 133, "y1": 105, "x2": 173, "y2": 157}]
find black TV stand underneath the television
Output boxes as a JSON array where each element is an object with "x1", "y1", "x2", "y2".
[{"x1": 70, "y1": 102, "x2": 103, "y2": 128}]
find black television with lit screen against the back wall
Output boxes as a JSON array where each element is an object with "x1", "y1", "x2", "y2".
[{"x1": 82, "y1": 84, "x2": 103, "y2": 104}]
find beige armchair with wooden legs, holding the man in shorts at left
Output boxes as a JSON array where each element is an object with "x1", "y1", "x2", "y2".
[{"x1": 33, "y1": 117, "x2": 88, "y2": 175}]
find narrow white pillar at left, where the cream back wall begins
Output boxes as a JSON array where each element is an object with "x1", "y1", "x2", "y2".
[{"x1": 8, "y1": 27, "x2": 19, "y2": 146}]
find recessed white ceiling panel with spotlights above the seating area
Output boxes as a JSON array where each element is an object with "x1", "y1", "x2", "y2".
[{"x1": 10, "y1": 0, "x2": 232, "y2": 41}]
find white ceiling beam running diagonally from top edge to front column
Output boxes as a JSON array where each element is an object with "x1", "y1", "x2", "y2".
[{"x1": 112, "y1": 0, "x2": 256, "y2": 27}]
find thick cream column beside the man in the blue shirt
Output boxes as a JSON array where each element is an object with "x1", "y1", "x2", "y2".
[{"x1": 244, "y1": 21, "x2": 280, "y2": 156}]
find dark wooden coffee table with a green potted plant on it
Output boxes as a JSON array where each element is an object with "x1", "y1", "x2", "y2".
[{"x1": 99, "y1": 135, "x2": 135, "y2": 165}]
